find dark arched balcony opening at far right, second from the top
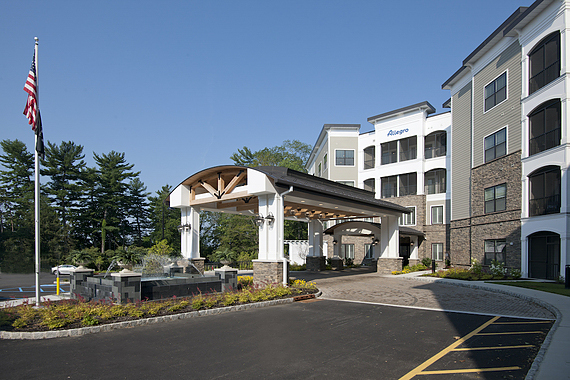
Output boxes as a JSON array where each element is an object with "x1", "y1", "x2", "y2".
[{"x1": 528, "y1": 99, "x2": 561, "y2": 155}]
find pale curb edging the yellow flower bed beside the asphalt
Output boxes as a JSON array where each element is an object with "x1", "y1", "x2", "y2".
[{"x1": 0, "y1": 298, "x2": 294, "y2": 339}]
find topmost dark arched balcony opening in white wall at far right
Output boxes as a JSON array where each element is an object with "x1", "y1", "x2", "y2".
[{"x1": 528, "y1": 32, "x2": 560, "y2": 94}]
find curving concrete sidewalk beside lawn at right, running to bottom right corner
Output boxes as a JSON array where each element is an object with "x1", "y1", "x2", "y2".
[{"x1": 397, "y1": 271, "x2": 570, "y2": 380}]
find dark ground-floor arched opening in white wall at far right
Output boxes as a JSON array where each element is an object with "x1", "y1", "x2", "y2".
[{"x1": 528, "y1": 232, "x2": 560, "y2": 280}]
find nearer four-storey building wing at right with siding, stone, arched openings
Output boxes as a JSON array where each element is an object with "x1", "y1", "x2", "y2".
[{"x1": 442, "y1": 0, "x2": 570, "y2": 279}]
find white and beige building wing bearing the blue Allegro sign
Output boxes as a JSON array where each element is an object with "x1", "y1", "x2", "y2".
[{"x1": 306, "y1": 102, "x2": 451, "y2": 264}]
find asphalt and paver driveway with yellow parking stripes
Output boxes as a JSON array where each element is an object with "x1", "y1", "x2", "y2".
[{"x1": 0, "y1": 271, "x2": 553, "y2": 380}]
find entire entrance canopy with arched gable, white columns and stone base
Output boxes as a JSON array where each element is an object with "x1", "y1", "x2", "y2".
[{"x1": 168, "y1": 165, "x2": 410, "y2": 282}]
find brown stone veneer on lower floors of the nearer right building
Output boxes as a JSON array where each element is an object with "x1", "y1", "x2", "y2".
[{"x1": 451, "y1": 151, "x2": 522, "y2": 269}]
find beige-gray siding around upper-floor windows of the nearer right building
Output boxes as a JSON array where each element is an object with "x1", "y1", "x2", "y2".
[{"x1": 473, "y1": 41, "x2": 522, "y2": 167}]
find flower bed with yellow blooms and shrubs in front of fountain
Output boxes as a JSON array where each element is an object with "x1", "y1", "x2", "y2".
[{"x1": 0, "y1": 279, "x2": 317, "y2": 331}]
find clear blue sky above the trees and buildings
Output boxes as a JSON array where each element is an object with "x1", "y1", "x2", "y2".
[{"x1": 0, "y1": 0, "x2": 532, "y2": 193}]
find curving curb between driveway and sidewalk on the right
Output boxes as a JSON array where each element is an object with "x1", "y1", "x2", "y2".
[{"x1": 398, "y1": 276, "x2": 562, "y2": 380}]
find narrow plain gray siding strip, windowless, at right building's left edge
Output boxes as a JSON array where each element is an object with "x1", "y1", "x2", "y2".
[{"x1": 451, "y1": 82, "x2": 472, "y2": 220}]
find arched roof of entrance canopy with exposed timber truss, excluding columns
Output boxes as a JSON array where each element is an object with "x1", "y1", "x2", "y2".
[{"x1": 169, "y1": 166, "x2": 409, "y2": 220}]
